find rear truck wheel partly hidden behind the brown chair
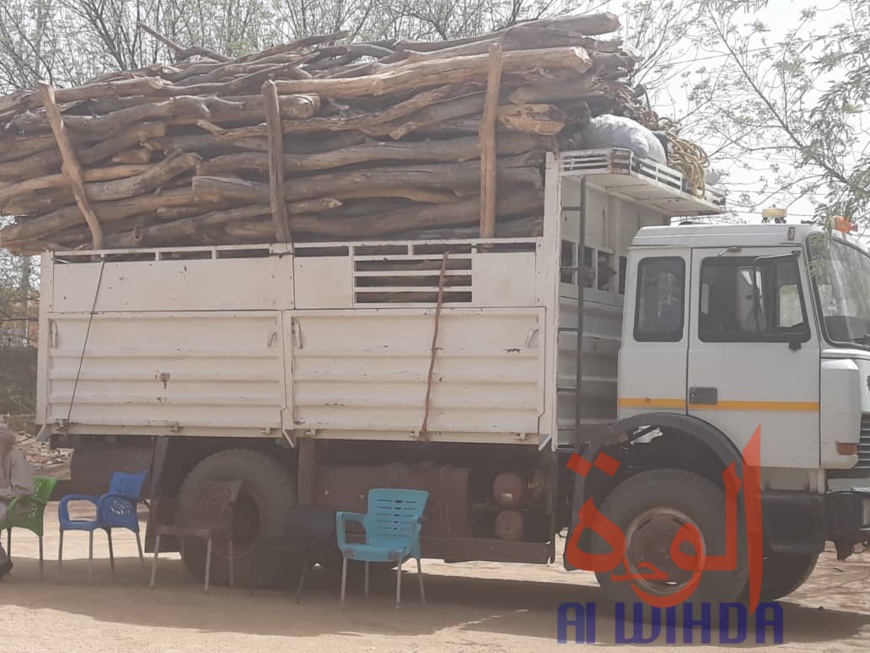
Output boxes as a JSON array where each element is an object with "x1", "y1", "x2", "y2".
[{"x1": 178, "y1": 449, "x2": 296, "y2": 587}]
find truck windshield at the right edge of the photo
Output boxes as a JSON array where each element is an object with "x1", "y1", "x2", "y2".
[{"x1": 808, "y1": 234, "x2": 870, "y2": 346}]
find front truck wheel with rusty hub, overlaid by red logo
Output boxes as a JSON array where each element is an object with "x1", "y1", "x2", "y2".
[{"x1": 591, "y1": 469, "x2": 748, "y2": 621}]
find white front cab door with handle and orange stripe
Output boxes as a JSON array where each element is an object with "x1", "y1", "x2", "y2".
[{"x1": 687, "y1": 246, "x2": 820, "y2": 469}]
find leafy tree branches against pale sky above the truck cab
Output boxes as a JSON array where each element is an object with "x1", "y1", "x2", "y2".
[{"x1": 684, "y1": 0, "x2": 870, "y2": 223}]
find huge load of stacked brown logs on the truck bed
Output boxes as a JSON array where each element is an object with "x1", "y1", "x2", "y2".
[{"x1": 0, "y1": 13, "x2": 652, "y2": 253}]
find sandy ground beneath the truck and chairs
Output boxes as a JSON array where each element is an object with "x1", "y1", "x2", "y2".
[{"x1": 0, "y1": 505, "x2": 870, "y2": 653}]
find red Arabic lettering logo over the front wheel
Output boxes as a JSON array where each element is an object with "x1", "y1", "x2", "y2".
[{"x1": 565, "y1": 425, "x2": 763, "y2": 614}]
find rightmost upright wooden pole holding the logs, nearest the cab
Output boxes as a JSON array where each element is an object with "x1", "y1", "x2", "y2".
[{"x1": 479, "y1": 43, "x2": 502, "y2": 238}]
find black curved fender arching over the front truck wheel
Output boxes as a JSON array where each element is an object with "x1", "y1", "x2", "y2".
[{"x1": 563, "y1": 413, "x2": 743, "y2": 570}]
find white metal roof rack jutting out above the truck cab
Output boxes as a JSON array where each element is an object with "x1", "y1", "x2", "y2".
[{"x1": 559, "y1": 148, "x2": 725, "y2": 217}]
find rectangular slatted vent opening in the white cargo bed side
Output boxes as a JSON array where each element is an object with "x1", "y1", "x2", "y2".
[{"x1": 353, "y1": 254, "x2": 471, "y2": 304}]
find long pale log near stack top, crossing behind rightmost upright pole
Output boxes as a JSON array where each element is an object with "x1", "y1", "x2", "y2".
[{"x1": 275, "y1": 47, "x2": 592, "y2": 98}]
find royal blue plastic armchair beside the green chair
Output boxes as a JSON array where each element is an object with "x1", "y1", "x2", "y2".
[{"x1": 57, "y1": 470, "x2": 148, "y2": 584}]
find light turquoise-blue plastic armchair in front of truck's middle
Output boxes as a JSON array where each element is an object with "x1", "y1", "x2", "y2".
[{"x1": 335, "y1": 489, "x2": 429, "y2": 610}]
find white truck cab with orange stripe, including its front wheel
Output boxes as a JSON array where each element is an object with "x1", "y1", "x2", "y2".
[{"x1": 575, "y1": 224, "x2": 870, "y2": 612}]
